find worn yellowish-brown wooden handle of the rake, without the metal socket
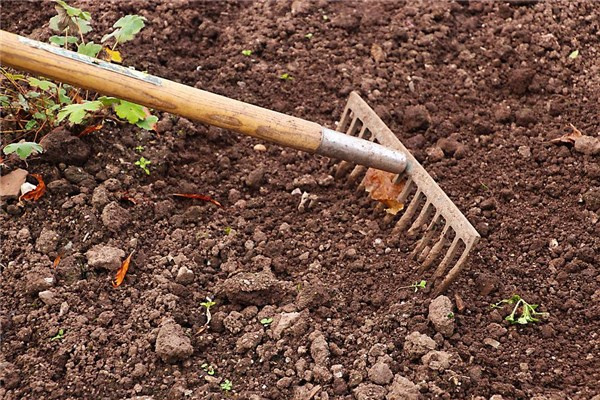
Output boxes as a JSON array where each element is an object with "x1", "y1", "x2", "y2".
[{"x1": 0, "y1": 31, "x2": 321, "y2": 153}]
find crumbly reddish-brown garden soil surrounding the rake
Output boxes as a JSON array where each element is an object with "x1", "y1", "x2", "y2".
[{"x1": 0, "y1": 0, "x2": 600, "y2": 400}]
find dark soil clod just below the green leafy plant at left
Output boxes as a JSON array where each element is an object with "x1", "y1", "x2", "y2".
[{"x1": 40, "y1": 127, "x2": 91, "y2": 165}]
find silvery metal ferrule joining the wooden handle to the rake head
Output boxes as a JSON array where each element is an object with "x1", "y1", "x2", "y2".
[{"x1": 316, "y1": 128, "x2": 406, "y2": 174}]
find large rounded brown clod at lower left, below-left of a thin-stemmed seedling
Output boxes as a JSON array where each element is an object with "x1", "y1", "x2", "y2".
[{"x1": 155, "y1": 318, "x2": 194, "y2": 364}]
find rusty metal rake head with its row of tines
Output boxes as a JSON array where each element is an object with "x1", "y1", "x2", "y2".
[{"x1": 336, "y1": 92, "x2": 480, "y2": 295}]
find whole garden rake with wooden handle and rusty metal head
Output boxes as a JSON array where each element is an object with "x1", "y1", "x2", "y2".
[{"x1": 0, "y1": 31, "x2": 479, "y2": 294}]
